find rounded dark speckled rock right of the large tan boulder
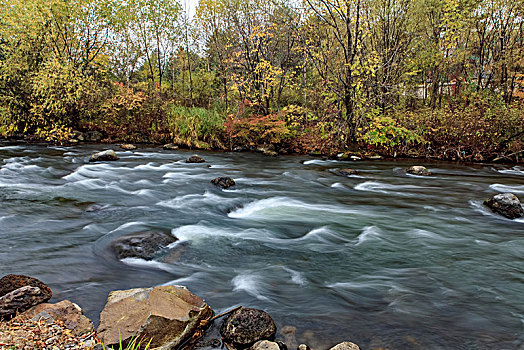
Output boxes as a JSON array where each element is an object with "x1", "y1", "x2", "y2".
[{"x1": 220, "y1": 307, "x2": 277, "y2": 348}]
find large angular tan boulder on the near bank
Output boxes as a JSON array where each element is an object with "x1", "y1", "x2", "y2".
[{"x1": 97, "y1": 286, "x2": 213, "y2": 350}]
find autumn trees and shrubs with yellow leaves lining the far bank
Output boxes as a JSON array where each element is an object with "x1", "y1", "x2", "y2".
[{"x1": 0, "y1": 0, "x2": 524, "y2": 162}]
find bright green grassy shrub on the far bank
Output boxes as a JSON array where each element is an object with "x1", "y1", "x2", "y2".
[{"x1": 166, "y1": 105, "x2": 224, "y2": 148}]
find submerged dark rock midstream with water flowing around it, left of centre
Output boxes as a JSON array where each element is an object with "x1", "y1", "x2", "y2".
[{"x1": 111, "y1": 231, "x2": 177, "y2": 260}]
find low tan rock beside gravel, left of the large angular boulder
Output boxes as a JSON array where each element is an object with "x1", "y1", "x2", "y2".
[{"x1": 16, "y1": 300, "x2": 95, "y2": 336}]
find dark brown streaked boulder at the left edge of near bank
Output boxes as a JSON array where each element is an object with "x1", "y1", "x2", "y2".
[{"x1": 0, "y1": 275, "x2": 53, "y2": 318}]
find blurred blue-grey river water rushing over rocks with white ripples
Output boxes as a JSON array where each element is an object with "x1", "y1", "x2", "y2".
[{"x1": 0, "y1": 144, "x2": 524, "y2": 349}]
